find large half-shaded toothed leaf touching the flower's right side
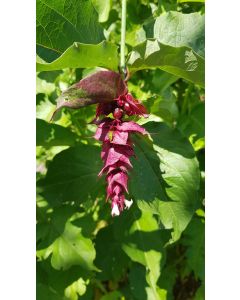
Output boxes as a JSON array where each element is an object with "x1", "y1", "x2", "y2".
[{"x1": 130, "y1": 122, "x2": 200, "y2": 242}]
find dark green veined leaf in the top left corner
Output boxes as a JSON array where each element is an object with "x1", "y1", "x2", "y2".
[{"x1": 36, "y1": 0, "x2": 104, "y2": 60}]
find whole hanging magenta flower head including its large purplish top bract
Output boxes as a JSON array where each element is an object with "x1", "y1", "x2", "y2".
[{"x1": 53, "y1": 71, "x2": 148, "y2": 216}]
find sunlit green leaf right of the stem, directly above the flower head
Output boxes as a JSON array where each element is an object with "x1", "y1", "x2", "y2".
[{"x1": 128, "y1": 39, "x2": 204, "y2": 86}]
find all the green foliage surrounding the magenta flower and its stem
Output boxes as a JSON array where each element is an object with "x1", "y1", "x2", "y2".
[{"x1": 36, "y1": 0, "x2": 205, "y2": 300}]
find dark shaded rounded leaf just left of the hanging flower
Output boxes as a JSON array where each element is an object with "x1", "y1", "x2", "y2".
[{"x1": 39, "y1": 145, "x2": 104, "y2": 206}]
